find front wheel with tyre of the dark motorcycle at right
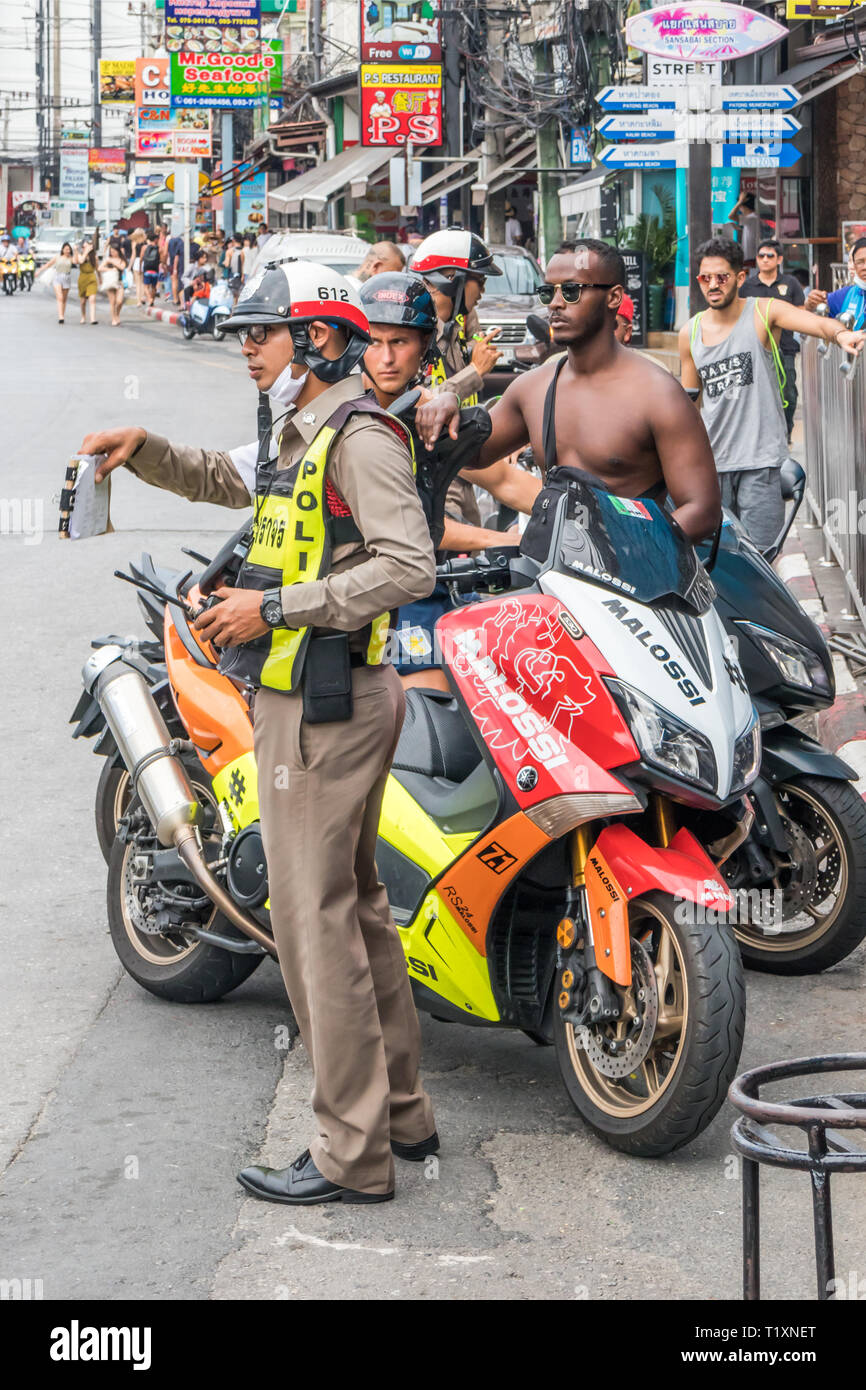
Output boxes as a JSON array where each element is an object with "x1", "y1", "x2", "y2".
[{"x1": 723, "y1": 777, "x2": 866, "y2": 974}]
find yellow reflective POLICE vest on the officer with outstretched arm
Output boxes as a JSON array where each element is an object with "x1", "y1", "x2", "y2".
[{"x1": 220, "y1": 396, "x2": 414, "y2": 694}]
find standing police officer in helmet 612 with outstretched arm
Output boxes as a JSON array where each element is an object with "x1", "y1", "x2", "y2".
[{"x1": 82, "y1": 261, "x2": 438, "y2": 1205}]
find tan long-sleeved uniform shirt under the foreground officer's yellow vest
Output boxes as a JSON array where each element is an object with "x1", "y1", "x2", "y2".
[{"x1": 126, "y1": 374, "x2": 435, "y2": 632}]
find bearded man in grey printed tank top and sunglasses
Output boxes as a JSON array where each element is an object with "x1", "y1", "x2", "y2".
[{"x1": 680, "y1": 236, "x2": 866, "y2": 549}]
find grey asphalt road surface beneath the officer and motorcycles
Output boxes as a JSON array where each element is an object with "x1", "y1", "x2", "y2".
[{"x1": 0, "y1": 284, "x2": 866, "y2": 1301}]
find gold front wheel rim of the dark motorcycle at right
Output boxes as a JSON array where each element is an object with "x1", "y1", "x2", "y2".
[{"x1": 733, "y1": 783, "x2": 848, "y2": 954}]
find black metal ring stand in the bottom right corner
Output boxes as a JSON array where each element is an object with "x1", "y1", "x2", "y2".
[{"x1": 728, "y1": 1052, "x2": 866, "y2": 1301}]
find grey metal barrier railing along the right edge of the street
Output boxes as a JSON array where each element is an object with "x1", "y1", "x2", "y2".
[{"x1": 801, "y1": 338, "x2": 866, "y2": 624}]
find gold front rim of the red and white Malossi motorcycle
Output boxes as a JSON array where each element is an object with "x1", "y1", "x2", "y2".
[{"x1": 564, "y1": 901, "x2": 688, "y2": 1119}]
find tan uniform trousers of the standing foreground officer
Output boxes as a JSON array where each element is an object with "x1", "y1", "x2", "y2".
[{"x1": 254, "y1": 666, "x2": 435, "y2": 1193}]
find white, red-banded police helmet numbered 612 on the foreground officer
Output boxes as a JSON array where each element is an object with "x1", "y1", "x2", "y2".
[{"x1": 221, "y1": 260, "x2": 370, "y2": 384}]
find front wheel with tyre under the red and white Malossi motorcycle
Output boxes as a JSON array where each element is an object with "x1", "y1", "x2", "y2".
[{"x1": 553, "y1": 892, "x2": 745, "y2": 1158}]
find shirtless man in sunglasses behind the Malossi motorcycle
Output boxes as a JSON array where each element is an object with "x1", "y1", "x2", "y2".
[{"x1": 416, "y1": 238, "x2": 721, "y2": 541}]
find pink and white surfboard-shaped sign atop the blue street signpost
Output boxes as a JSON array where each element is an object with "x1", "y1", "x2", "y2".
[{"x1": 626, "y1": 0, "x2": 788, "y2": 63}]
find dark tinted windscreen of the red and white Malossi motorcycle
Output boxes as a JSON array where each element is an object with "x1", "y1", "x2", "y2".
[{"x1": 559, "y1": 480, "x2": 716, "y2": 614}]
